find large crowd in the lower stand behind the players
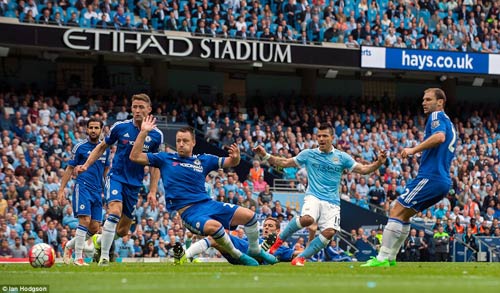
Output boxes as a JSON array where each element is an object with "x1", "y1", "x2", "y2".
[{"x1": 0, "y1": 86, "x2": 500, "y2": 256}]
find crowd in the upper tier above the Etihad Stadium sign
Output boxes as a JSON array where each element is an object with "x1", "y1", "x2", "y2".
[{"x1": 0, "y1": 0, "x2": 500, "y2": 53}]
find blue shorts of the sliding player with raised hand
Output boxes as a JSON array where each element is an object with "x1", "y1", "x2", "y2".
[{"x1": 181, "y1": 199, "x2": 239, "y2": 236}]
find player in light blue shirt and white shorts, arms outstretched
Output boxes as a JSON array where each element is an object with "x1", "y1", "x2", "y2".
[{"x1": 254, "y1": 123, "x2": 386, "y2": 266}]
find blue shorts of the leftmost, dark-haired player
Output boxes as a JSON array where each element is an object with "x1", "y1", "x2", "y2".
[{"x1": 73, "y1": 182, "x2": 102, "y2": 222}]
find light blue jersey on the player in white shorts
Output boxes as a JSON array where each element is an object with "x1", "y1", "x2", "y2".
[{"x1": 294, "y1": 148, "x2": 356, "y2": 205}]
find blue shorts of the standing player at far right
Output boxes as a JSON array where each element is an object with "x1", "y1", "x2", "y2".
[{"x1": 398, "y1": 177, "x2": 451, "y2": 212}]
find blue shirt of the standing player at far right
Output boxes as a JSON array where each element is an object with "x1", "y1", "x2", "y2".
[{"x1": 418, "y1": 111, "x2": 457, "y2": 184}]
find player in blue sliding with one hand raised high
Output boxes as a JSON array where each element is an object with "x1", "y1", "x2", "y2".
[{"x1": 130, "y1": 116, "x2": 277, "y2": 266}]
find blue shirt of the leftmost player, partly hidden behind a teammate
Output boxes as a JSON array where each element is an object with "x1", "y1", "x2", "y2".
[{"x1": 68, "y1": 140, "x2": 109, "y2": 192}]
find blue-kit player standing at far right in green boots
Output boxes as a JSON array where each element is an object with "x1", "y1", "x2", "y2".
[{"x1": 361, "y1": 88, "x2": 457, "y2": 267}]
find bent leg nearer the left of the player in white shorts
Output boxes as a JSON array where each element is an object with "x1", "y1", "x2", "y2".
[{"x1": 269, "y1": 195, "x2": 320, "y2": 254}]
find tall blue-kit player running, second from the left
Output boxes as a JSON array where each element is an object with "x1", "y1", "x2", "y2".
[{"x1": 76, "y1": 94, "x2": 163, "y2": 266}]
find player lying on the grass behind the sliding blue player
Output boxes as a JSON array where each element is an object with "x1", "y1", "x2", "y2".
[{"x1": 174, "y1": 218, "x2": 299, "y2": 265}]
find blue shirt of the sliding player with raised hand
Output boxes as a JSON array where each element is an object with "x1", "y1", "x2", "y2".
[{"x1": 147, "y1": 152, "x2": 224, "y2": 212}]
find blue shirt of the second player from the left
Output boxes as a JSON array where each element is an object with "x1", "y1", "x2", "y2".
[{"x1": 105, "y1": 119, "x2": 163, "y2": 186}]
